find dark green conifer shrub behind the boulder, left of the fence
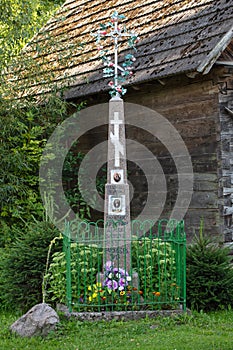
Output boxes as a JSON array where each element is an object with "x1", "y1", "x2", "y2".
[{"x1": 0, "y1": 222, "x2": 61, "y2": 310}]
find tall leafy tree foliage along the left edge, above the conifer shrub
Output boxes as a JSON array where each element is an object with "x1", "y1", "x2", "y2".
[{"x1": 0, "y1": 0, "x2": 89, "y2": 246}]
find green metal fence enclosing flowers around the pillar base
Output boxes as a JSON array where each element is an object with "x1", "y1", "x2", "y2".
[{"x1": 63, "y1": 220, "x2": 186, "y2": 312}]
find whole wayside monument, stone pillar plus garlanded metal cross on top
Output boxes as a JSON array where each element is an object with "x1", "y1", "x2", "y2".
[{"x1": 94, "y1": 12, "x2": 138, "y2": 282}]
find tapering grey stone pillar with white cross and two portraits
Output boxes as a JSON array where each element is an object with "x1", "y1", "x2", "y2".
[{"x1": 104, "y1": 96, "x2": 131, "y2": 272}]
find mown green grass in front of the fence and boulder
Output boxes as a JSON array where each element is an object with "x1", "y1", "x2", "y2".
[{"x1": 0, "y1": 311, "x2": 233, "y2": 350}]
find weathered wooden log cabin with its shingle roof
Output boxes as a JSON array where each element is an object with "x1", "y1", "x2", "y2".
[{"x1": 11, "y1": 0, "x2": 233, "y2": 242}]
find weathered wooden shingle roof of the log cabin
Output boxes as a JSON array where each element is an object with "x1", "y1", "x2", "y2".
[{"x1": 9, "y1": 0, "x2": 233, "y2": 98}]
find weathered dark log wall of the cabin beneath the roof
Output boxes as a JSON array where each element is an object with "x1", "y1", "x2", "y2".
[{"x1": 72, "y1": 73, "x2": 229, "y2": 240}]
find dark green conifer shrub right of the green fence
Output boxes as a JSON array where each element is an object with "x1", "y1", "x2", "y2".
[{"x1": 187, "y1": 233, "x2": 233, "y2": 311}]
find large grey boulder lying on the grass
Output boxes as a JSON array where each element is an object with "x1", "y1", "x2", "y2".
[{"x1": 10, "y1": 303, "x2": 59, "y2": 337}]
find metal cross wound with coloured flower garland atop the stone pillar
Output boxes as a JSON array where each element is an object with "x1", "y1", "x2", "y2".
[{"x1": 93, "y1": 11, "x2": 139, "y2": 97}]
